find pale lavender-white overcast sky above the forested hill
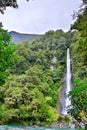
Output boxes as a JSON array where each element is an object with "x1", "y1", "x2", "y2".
[{"x1": 0, "y1": 0, "x2": 81, "y2": 34}]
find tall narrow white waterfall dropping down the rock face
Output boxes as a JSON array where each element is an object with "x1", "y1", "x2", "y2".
[{"x1": 60, "y1": 48, "x2": 71, "y2": 115}]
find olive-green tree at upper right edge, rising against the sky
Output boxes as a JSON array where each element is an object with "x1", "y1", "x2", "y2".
[{"x1": 71, "y1": 3, "x2": 87, "y2": 65}]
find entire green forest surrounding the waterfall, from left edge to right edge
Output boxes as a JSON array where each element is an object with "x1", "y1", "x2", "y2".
[{"x1": 0, "y1": 0, "x2": 87, "y2": 127}]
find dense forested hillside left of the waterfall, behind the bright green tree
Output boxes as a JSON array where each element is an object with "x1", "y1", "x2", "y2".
[{"x1": 0, "y1": 30, "x2": 77, "y2": 125}]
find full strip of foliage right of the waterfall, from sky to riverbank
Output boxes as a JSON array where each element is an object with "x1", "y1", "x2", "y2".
[{"x1": 69, "y1": 6, "x2": 87, "y2": 127}]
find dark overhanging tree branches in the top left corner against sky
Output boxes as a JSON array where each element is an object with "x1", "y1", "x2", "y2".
[{"x1": 0, "y1": 0, "x2": 29, "y2": 14}]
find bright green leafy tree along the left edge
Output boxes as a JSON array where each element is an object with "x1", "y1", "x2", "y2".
[{"x1": 0, "y1": 29, "x2": 16, "y2": 85}]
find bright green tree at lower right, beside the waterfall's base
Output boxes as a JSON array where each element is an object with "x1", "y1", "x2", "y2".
[{"x1": 69, "y1": 80, "x2": 87, "y2": 125}]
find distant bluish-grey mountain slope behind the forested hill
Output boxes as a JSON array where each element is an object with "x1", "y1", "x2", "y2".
[{"x1": 9, "y1": 31, "x2": 40, "y2": 44}]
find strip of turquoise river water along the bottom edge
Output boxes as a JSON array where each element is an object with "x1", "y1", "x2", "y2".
[{"x1": 0, "y1": 125, "x2": 82, "y2": 130}]
